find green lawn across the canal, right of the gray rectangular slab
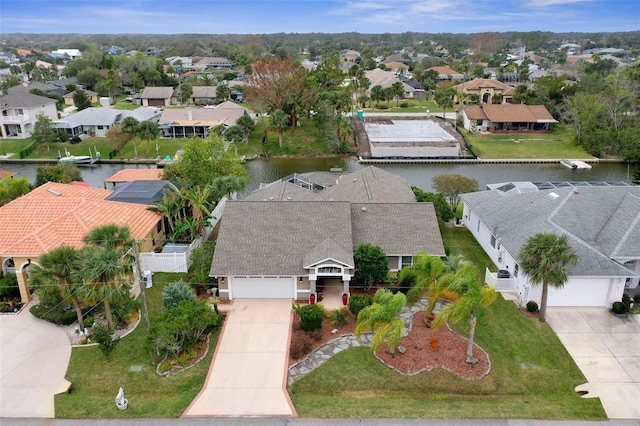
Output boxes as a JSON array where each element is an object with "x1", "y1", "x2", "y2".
[{"x1": 462, "y1": 126, "x2": 592, "y2": 159}]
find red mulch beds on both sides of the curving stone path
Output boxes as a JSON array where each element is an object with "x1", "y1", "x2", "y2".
[{"x1": 289, "y1": 312, "x2": 490, "y2": 379}]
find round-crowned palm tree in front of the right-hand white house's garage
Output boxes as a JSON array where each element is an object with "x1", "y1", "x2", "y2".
[{"x1": 520, "y1": 232, "x2": 578, "y2": 322}]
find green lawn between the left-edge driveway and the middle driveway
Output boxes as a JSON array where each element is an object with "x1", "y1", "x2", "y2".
[{"x1": 55, "y1": 273, "x2": 219, "y2": 418}]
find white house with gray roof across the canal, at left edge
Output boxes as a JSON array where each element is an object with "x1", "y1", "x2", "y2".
[{"x1": 0, "y1": 90, "x2": 58, "y2": 139}]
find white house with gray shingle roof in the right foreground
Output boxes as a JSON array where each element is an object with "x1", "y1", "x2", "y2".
[{"x1": 461, "y1": 182, "x2": 640, "y2": 308}]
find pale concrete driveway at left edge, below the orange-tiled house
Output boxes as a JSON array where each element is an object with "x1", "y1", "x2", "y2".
[{"x1": 0, "y1": 305, "x2": 71, "y2": 418}]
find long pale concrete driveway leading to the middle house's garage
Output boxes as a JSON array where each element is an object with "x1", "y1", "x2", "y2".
[{"x1": 183, "y1": 299, "x2": 295, "y2": 417}]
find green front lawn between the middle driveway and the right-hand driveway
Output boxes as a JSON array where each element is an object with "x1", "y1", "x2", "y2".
[{"x1": 290, "y1": 228, "x2": 606, "y2": 420}]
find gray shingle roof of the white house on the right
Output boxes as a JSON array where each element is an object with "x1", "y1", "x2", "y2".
[{"x1": 461, "y1": 186, "x2": 640, "y2": 277}]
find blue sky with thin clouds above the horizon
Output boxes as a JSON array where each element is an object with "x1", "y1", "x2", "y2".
[{"x1": 0, "y1": 0, "x2": 640, "y2": 34}]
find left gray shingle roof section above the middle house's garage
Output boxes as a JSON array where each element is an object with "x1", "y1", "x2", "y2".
[{"x1": 211, "y1": 201, "x2": 353, "y2": 276}]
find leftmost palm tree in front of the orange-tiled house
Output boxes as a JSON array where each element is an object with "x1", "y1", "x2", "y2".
[{"x1": 31, "y1": 245, "x2": 84, "y2": 330}]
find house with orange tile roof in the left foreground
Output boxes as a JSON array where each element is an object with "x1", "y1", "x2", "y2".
[{"x1": 0, "y1": 182, "x2": 165, "y2": 303}]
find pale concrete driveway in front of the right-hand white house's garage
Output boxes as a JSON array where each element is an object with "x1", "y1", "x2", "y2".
[{"x1": 547, "y1": 308, "x2": 640, "y2": 419}]
